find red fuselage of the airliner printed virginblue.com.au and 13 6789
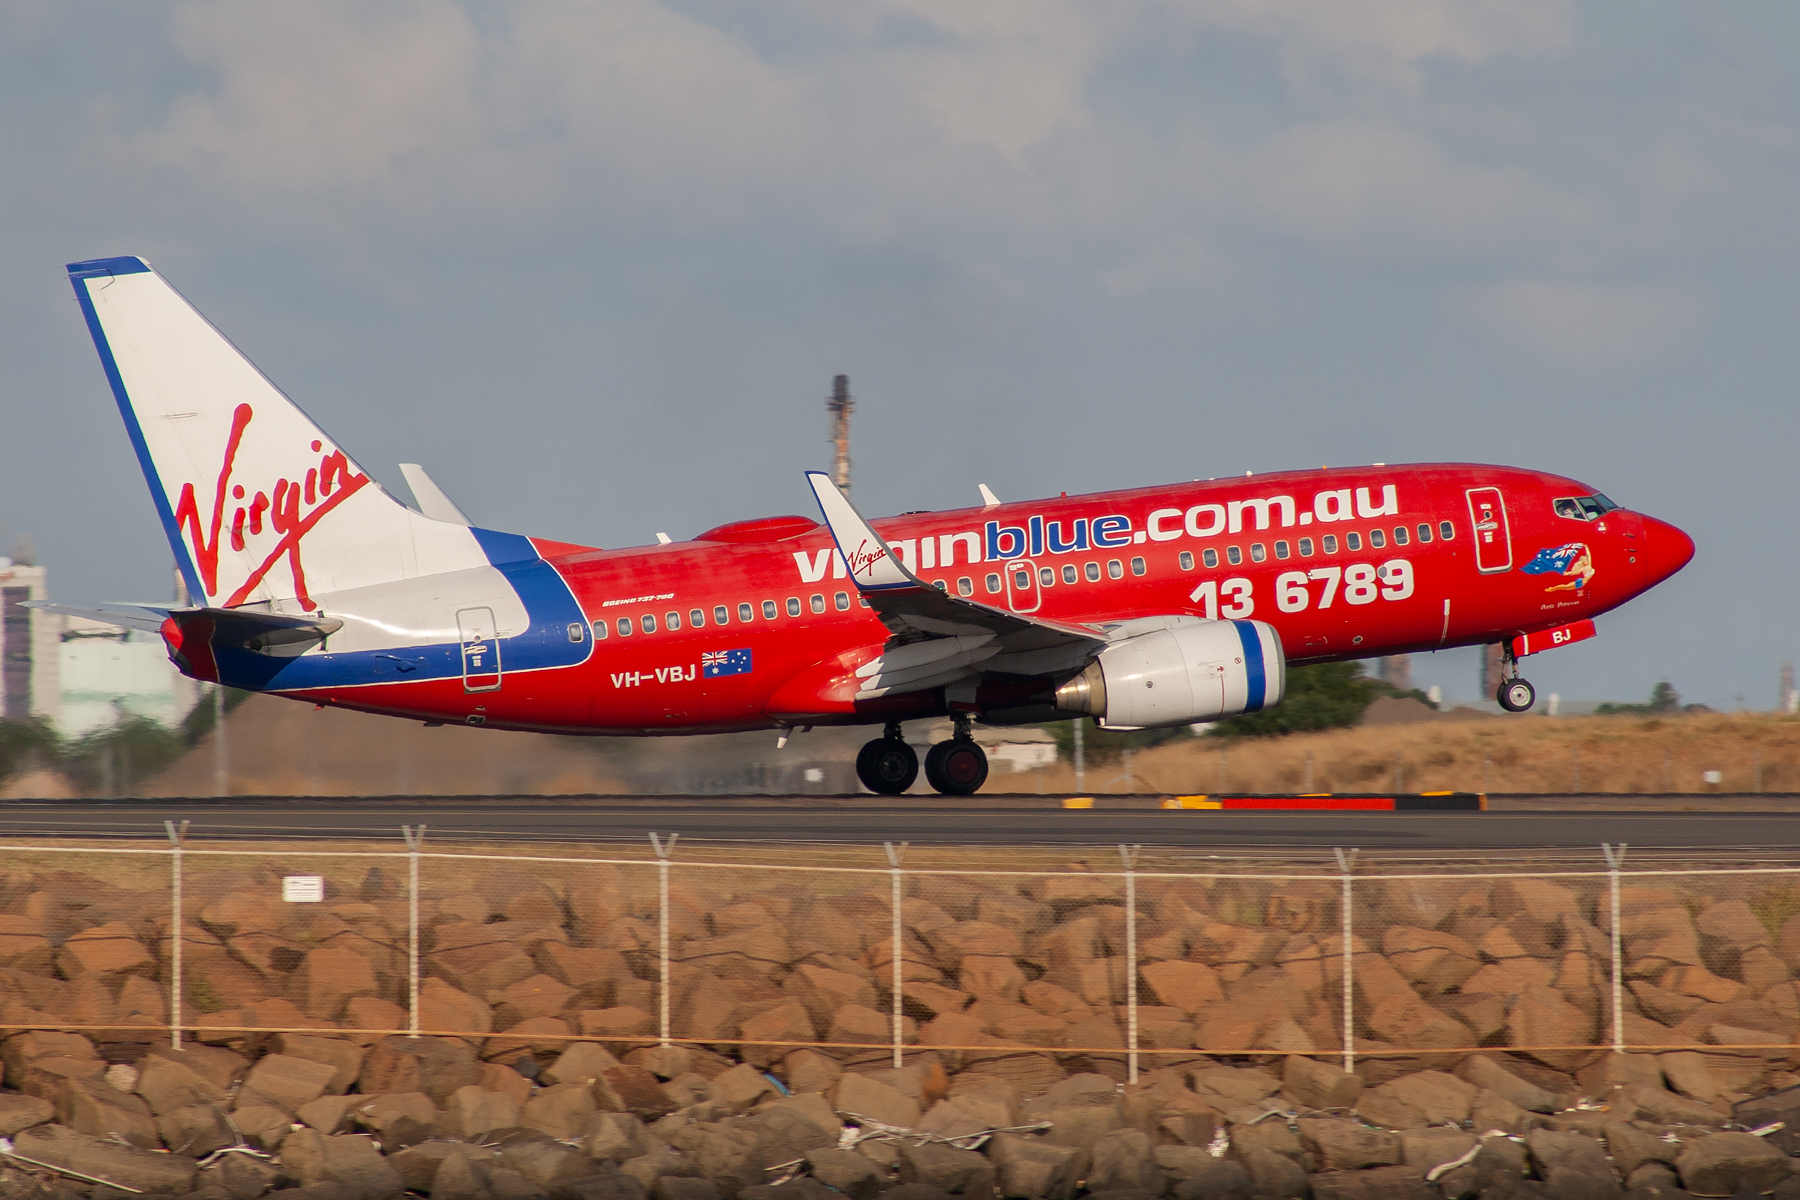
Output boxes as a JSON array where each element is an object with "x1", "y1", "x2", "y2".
[{"x1": 284, "y1": 464, "x2": 1694, "y2": 734}]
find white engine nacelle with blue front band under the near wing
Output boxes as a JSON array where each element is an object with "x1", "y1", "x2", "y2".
[{"x1": 1057, "y1": 617, "x2": 1287, "y2": 729}]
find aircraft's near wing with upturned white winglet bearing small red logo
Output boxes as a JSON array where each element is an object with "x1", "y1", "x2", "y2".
[{"x1": 806, "y1": 471, "x2": 1107, "y2": 696}]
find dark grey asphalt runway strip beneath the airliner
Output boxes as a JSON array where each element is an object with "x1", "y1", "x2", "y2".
[{"x1": 0, "y1": 795, "x2": 1800, "y2": 858}]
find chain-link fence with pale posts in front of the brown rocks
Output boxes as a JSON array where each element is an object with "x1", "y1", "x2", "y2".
[{"x1": 0, "y1": 841, "x2": 1800, "y2": 1092}]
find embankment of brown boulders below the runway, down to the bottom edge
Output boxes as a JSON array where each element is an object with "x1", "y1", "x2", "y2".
[{"x1": 0, "y1": 860, "x2": 1800, "y2": 1200}]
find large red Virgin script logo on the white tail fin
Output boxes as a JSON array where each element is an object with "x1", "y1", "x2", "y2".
[{"x1": 175, "y1": 405, "x2": 369, "y2": 608}]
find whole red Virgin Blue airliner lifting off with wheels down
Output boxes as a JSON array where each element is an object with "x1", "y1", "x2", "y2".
[{"x1": 50, "y1": 257, "x2": 1694, "y2": 795}]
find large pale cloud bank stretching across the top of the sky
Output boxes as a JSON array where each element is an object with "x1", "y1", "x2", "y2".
[{"x1": 90, "y1": 0, "x2": 1588, "y2": 273}]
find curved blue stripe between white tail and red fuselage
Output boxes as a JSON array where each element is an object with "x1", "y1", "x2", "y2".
[{"x1": 216, "y1": 529, "x2": 594, "y2": 691}]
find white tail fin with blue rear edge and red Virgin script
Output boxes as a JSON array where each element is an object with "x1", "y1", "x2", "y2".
[{"x1": 68, "y1": 257, "x2": 488, "y2": 610}]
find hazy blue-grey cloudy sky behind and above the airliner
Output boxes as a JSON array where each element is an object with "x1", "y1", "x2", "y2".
[{"x1": 0, "y1": 0, "x2": 1800, "y2": 709}]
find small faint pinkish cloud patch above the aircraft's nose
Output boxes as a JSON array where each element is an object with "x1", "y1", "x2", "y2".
[{"x1": 1462, "y1": 279, "x2": 1701, "y2": 367}]
